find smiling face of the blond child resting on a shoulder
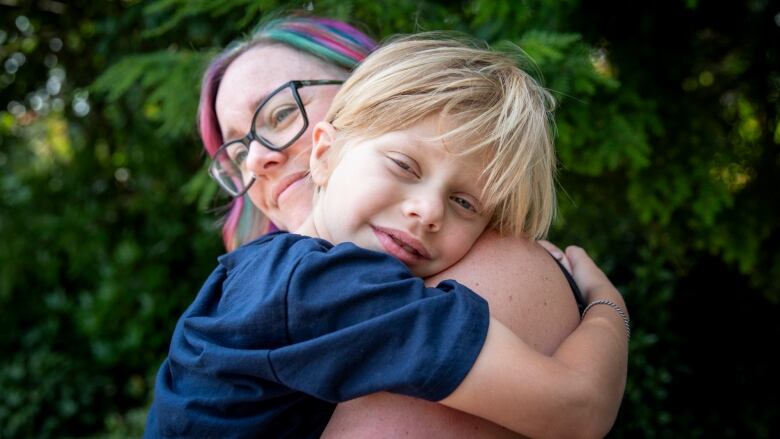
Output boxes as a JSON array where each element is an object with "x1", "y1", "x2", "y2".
[{"x1": 312, "y1": 117, "x2": 490, "y2": 277}]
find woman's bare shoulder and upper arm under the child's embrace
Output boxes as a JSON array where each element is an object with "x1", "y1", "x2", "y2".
[{"x1": 323, "y1": 232, "x2": 596, "y2": 438}]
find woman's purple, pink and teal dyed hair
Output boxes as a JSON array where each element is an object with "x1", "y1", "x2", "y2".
[{"x1": 198, "y1": 16, "x2": 376, "y2": 251}]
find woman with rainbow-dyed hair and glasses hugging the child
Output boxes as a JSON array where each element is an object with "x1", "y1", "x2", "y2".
[{"x1": 199, "y1": 17, "x2": 626, "y2": 437}]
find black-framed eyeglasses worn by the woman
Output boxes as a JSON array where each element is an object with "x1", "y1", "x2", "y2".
[{"x1": 209, "y1": 79, "x2": 344, "y2": 197}]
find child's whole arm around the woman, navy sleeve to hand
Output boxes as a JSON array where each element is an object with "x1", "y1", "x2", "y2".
[{"x1": 282, "y1": 239, "x2": 627, "y2": 436}]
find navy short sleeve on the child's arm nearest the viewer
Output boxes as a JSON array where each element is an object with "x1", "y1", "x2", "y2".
[{"x1": 269, "y1": 244, "x2": 489, "y2": 402}]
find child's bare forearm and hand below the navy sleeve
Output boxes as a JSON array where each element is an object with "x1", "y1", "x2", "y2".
[{"x1": 440, "y1": 247, "x2": 628, "y2": 437}]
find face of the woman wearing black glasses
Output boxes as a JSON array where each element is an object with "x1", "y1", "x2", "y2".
[{"x1": 216, "y1": 45, "x2": 345, "y2": 230}]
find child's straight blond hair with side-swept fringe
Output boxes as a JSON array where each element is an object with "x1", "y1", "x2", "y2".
[{"x1": 326, "y1": 33, "x2": 555, "y2": 239}]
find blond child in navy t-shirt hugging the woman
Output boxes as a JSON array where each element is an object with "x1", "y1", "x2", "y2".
[{"x1": 146, "y1": 37, "x2": 625, "y2": 437}]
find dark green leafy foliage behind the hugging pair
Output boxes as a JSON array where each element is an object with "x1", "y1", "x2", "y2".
[{"x1": 0, "y1": 0, "x2": 780, "y2": 438}]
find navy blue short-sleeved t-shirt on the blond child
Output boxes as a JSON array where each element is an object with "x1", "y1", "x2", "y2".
[{"x1": 146, "y1": 232, "x2": 489, "y2": 438}]
